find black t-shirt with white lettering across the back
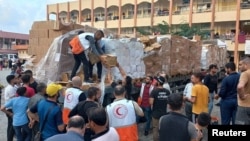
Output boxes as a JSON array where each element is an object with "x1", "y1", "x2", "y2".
[{"x1": 150, "y1": 88, "x2": 170, "y2": 119}]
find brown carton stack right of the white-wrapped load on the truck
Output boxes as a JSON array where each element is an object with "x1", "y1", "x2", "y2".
[{"x1": 143, "y1": 36, "x2": 202, "y2": 76}]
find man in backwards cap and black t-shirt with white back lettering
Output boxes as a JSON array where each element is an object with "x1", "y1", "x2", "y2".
[{"x1": 149, "y1": 76, "x2": 170, "y2": 141}]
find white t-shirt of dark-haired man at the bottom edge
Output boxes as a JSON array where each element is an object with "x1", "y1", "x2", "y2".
[{"x1": 92, "y1": 127, "x2": 120, "y2": 141}]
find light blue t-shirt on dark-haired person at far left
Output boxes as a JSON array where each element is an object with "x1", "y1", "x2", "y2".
[{"x1": 4, "y1": 96, "x2": 29, "y2": 126}]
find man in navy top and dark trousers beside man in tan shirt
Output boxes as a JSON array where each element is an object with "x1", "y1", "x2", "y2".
[{"x1": 215, "y1": 62, "x2": 240, "y2": 125}]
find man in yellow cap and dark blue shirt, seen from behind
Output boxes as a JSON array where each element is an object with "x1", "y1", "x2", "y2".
[{"x1": 28, "y1": 83, "x2": 65, "y2": 140}]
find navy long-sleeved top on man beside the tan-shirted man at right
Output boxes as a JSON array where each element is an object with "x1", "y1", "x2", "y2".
[{"x1": 219, "y1": 72, "x2": 240, "y2": 99}]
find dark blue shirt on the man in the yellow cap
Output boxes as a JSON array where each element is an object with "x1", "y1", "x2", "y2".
[{"x1": 30, "y1": 99, "x2": 63, "y2": 140}]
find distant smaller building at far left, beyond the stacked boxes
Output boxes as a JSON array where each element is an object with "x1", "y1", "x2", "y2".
[{"x1": 0, "y1": 31, "x2": 29, "y2": 54}]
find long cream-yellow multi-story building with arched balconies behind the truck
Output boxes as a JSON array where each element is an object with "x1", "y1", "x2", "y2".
[{"x1": 47, "y1": 0, "x2": 250, "y2": 58}]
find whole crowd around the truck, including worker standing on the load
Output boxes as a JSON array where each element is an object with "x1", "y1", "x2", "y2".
[{"x1": 1, "y1": 28, "x2": 250, "y2": 141}]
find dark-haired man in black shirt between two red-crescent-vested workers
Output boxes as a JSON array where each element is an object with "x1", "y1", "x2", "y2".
[{"x1": 69, "y1": 87, "x2": 101, "y2": 141}]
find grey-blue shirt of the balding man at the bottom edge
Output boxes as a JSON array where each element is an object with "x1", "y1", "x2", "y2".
[{"x1": 45, "y1": 131, "x2": 84, "y2": 141}]
